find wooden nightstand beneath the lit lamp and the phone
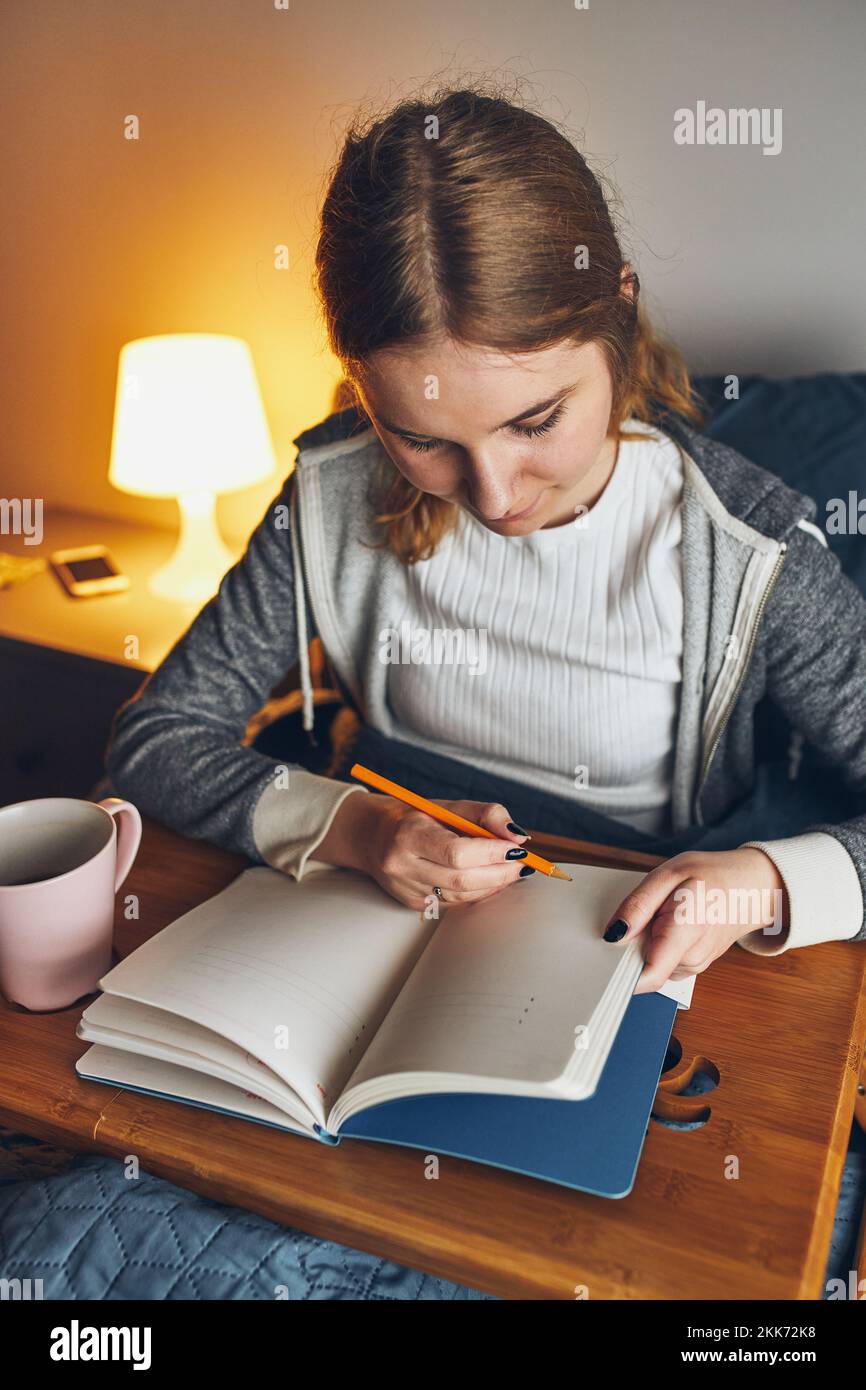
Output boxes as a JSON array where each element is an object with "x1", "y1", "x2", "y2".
[{"x1": 0, "y1": 507, "x2": 230, "y2": 805}]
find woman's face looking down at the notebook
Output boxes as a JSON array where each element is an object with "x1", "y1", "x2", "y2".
[{"x1": 361, "y1": 338, "x2": 617, "y2": 535}]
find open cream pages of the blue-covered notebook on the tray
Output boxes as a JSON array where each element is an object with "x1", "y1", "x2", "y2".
[{"x1": 76, "y1": 865, "x2": 694, "y2": 1186}]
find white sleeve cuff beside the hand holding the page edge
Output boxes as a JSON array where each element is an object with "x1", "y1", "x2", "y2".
[{"x1": 738, "y1": 831, "x2": 863, "y2": 955}]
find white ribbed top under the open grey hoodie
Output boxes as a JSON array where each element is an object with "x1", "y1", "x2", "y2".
[{"x1": 388, "y1": 418, "x2": 683, "y2": 833}]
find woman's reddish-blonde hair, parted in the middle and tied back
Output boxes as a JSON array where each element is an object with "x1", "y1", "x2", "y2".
[{"x1": 316, "y1": 78, "x2": 703, "y2": 564}]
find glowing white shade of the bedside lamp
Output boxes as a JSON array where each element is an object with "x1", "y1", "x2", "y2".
[{"x1": 108, "y1": 334, "x2": 277, "y2": 498}]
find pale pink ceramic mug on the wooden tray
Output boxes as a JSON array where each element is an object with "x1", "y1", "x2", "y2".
[{"x1": 0, "y1": 796, "x2": 142, "y2": 1011}]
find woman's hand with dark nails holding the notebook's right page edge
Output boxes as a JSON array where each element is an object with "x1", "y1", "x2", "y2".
[{"x1": 606, "y1": 848, "x2": 788, "y2": 994}]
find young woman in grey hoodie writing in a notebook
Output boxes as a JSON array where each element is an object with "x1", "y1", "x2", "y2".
[{"x1": 108, "y1": 90, "x2": 866, "y2": 991}]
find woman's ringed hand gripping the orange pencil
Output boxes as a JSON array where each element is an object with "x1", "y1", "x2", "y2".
[{"x1": 313, "y1": 792, "x2": 534, "y2": 910}]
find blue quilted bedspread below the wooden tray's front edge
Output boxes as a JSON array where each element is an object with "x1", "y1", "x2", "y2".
[{"x1": 0, "y1": 1154, "x2": 495, "y2": 1301}]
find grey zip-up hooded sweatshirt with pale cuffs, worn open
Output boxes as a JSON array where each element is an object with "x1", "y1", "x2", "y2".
[{"x1": 107, "y1": 409, "x2": 866, "y2": 955}]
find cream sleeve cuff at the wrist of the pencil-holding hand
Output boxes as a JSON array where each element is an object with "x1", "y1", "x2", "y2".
[{"x1": 253, "y1": 767, "x2": 368, "y2": 883}]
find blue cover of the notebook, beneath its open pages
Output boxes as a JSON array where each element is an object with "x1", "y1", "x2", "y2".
[{"x1": 76, "y1": 994, "x2": 677, "y2": 1197}]
